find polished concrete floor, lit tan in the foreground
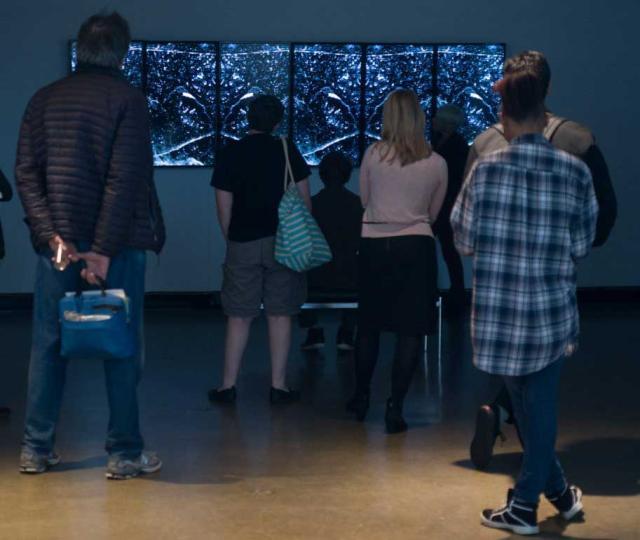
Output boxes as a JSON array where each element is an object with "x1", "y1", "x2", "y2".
[{"x1": 0, "y1": 304, "x2": 640, "y2": 540}]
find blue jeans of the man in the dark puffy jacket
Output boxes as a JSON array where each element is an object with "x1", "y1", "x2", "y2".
[{"x1": 23, "y1": 245, "x2": 146, "y2": 459}]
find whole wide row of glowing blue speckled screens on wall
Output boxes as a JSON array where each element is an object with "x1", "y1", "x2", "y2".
[{"x1": 70, "y1": 41, "x2": 504, "y2": 167}]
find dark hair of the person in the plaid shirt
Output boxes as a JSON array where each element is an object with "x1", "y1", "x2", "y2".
[{"x1": 494, "y1": 70, "x2": 545, "y2": 122}]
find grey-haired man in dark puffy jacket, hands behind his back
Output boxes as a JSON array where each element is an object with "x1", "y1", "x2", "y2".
[{"x1": 15, "y1": 13, "x2": 164, "y2": 479}]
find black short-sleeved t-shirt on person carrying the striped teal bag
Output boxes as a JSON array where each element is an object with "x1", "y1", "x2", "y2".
[{"x1": 211, "y1": 133, "x2": 311, "y2": 242}]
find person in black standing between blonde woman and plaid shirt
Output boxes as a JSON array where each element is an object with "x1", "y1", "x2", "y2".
[{"x1": 432, "y1": 105, "x2": 469, "y2": 315}]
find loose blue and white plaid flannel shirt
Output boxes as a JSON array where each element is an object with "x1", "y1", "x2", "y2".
[{"x1": 451, "y1": 134, "x2": 598, "y2": 376}]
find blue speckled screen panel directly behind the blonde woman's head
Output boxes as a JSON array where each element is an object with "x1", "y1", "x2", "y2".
[{"x1": 365, "y1": 44, "x2": 435, "y2": 145}]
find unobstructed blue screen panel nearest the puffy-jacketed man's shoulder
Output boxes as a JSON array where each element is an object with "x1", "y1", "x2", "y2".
[{"x1": 146, "y1": 43, "x2": 217, "y2": 167}]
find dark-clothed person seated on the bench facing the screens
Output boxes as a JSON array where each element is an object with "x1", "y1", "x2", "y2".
[{"x1": 299, "y1": 152, "x2": 362, "y2": 351}]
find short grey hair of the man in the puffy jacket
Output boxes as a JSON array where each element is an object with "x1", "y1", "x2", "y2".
[{"x1": 77, "y1": 11, "x2": 131, "y2": 69}]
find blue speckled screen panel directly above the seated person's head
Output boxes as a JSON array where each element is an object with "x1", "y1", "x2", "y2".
[{"x1": 293, "y1": 44, "x2": 362, "y2": 165}]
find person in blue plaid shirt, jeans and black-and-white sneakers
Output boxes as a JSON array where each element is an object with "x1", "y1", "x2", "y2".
[{"x1": 451, "y1": 56, "x2": 598, "y2": 534}]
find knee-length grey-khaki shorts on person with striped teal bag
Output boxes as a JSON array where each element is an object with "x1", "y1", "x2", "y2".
[{"x1": 221, "y1": 236, "x2": 307, "y2": 318}]
